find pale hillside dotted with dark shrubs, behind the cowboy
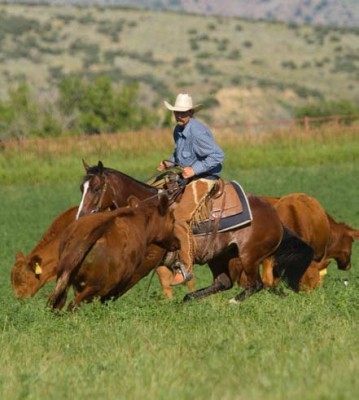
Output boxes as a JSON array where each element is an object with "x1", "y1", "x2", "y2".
[{"x1": 0, "y1": 4, "x2": 359, "y2": 124}]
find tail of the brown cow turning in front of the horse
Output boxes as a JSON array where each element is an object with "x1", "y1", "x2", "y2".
[{"x1": 47, "y1": 213, "x2": 117, "y2": 309}]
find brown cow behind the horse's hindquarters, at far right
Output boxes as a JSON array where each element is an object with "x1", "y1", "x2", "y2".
[{"x1": 262, "y1": 193, "x2": 359, "y2": 290}]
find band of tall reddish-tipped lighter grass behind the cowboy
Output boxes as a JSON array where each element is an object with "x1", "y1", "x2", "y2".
[{"x1": 0, "y1": 123, "x2": 359, "y2": 185}]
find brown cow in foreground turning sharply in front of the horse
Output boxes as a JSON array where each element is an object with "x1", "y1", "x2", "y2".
[{"x1": 48, "y1": 194, "x2": 179, "y2": 309}]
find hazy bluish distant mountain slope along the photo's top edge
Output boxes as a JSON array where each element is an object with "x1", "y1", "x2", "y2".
[{"x1": 0, "y1": 0, "x2": 359, "y2": 27}]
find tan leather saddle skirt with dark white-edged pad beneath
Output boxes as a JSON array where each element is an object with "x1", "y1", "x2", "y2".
[{"x1": 193, "y1": 181, "x2": 253, "y2": 235}]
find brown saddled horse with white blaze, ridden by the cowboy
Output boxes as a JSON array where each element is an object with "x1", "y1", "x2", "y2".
[{"x1": 74, "y1": 162, "x2": 313, "y2": 301}]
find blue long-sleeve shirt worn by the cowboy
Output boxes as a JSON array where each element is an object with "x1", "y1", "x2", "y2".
[{"x1": 170, "y1": 118, "x2": 224, "y2": 176}]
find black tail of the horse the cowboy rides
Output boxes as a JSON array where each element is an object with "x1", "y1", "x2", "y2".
[{"x1": 273, "y1": 227, "x2": 314, "y2": 291}]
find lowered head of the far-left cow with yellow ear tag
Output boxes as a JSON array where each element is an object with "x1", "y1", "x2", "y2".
[{"x1": 11, "y1": 251, "x2": 43, "y2": 298}]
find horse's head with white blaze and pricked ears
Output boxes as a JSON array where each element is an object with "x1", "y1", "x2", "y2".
[{"x1": 76, "y1": 160, "x2": 117, "y2": 219}]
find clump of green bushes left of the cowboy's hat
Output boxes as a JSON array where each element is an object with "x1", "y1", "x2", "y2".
[{"x1": 0, "y1": 76, "x2": 159, "y2": 140}]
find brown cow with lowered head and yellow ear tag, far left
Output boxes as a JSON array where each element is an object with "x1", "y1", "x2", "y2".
[{"x1": 11, "y1": 207, "x2": 77, "y2": 298}]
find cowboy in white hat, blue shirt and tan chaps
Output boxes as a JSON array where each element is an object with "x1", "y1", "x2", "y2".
[{"x1": 157, "y1": 93, "x2": 224, "y2": 286}]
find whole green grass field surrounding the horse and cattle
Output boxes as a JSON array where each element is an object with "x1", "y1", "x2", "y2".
[{"x1": 0, "y1": 129, "x2": 359, "y2": 400}]
